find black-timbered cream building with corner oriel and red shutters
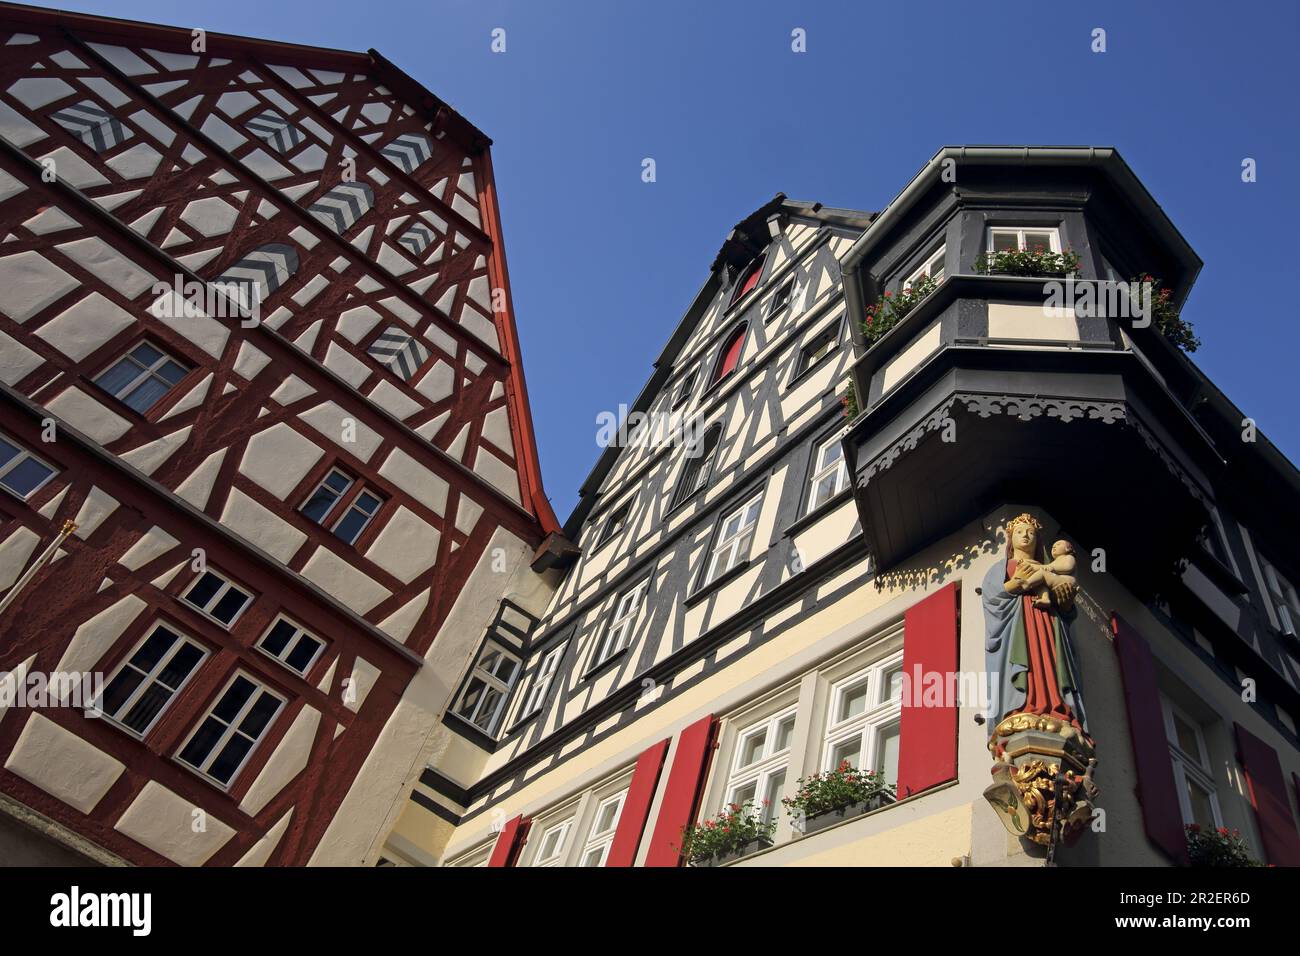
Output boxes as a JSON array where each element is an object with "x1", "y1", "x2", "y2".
[{"x1": 384, "y1": 147, "x2": 1300, "y2": 866}]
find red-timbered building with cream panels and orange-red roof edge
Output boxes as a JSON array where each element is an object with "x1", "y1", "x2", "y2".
[{"x1": 0, "y1": 5, "x2": 558, "y2": 865}]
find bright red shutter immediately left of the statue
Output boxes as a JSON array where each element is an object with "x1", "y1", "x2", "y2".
[{"x1": 898, "y1": 581, "x2": 957, "y2": 800}]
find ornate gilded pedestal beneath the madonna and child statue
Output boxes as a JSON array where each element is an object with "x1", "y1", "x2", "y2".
[{"x1": 984, "y1": 714, "x2": 1100, "y2": 847}]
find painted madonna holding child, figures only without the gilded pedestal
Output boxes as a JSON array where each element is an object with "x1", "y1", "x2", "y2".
[{"x1": 982, "y1": 514, "x2": 1091, "y2": 744}]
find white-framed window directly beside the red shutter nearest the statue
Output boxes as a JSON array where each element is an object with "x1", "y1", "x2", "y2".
[{"x1": 822, "y1": 657, "x2": 902, "y2": 784}]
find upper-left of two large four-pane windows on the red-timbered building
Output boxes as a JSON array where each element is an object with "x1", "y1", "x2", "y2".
[{"x1": 99, "y1": 624, "x2": 208, "y2": 737}]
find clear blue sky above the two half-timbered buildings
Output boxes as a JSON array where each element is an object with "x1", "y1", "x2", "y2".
[{"x1": 35, "y1": 0, "x2": 1300, "y2": 520}]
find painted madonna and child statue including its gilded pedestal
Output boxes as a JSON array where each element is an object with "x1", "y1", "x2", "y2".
[{"x1": 980, "y1": 514, "x2": 1097, "y2": 849}]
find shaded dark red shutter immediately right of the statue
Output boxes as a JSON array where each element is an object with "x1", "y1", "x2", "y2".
[{"x1": 1110, "y1": 614, "x2": 1187, "y2": 862}]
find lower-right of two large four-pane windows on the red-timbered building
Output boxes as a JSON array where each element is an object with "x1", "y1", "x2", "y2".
[{"x1": 179, "y1": 672, "x2": 285, "y2": 787}]
